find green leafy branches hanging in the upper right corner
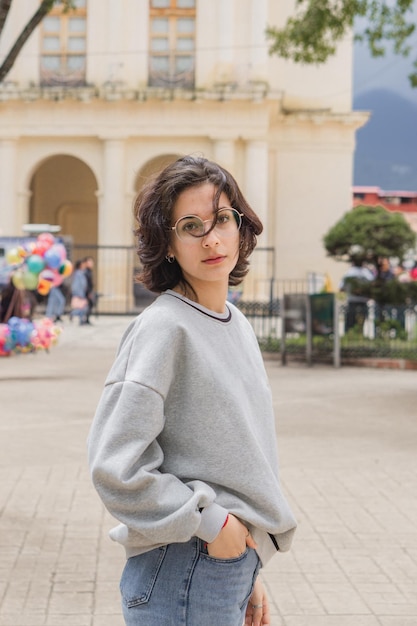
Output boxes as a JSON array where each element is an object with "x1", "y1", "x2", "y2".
[{"x1": 266, "y1": 0, "x2": 417, "y2": 87}]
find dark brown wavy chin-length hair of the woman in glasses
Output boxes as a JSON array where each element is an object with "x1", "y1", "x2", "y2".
[{"x1": 134, "y1": 156, "x2": 263, "y2": 293}]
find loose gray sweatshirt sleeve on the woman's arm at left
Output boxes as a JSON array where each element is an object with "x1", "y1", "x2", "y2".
[{"x1": 88, "y1": 314, "x2": 227, "y2": 545}]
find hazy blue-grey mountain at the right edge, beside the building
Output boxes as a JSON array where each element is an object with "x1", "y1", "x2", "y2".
[{"x1": 353, "y1": 89, "x2": 417, "y2": 191}]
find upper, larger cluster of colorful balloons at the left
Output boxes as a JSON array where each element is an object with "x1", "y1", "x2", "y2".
[{"x1": 6, "y1": 233, "x2": 72, "y2": 296}]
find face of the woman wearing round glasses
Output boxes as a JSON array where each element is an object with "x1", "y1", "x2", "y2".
[{"x1": 169, "y1": 183, "x2": 239, "y2": 294}]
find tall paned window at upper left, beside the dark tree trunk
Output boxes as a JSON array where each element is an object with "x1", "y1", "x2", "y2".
[{"x1": 40, "y1": 0, "x2": 87, "y2": 86}]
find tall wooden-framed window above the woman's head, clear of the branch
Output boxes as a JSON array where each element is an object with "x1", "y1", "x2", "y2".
[{"x1": 149, "y1": 0, "x2": 196, "y2": 89}]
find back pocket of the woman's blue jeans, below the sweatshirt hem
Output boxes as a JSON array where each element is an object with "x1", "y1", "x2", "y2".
[{"x1": 120, "y1": 546, "x2": 167, "y2": 608}]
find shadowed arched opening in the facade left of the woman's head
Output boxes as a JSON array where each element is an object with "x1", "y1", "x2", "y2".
[{"x1": 29, "y1": 154, "x2": 98, "y2": 245}]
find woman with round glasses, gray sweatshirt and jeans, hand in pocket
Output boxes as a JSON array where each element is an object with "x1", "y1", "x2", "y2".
[{"x1": 89, "y1": 156, "x2": 295, "y2": 626}]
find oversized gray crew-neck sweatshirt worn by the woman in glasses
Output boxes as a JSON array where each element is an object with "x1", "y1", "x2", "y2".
[{"x1": 88, "y1": 291, "x2": 296, "y2": 565}]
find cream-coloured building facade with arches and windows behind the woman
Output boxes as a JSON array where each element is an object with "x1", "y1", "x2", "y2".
[{"x1": 0, "y1": 0, "x2": 367, "y2": 306}]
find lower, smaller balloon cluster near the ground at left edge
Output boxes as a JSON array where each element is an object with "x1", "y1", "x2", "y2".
[{"x1": 0, "y1": 317, "x2": 60, "y2": 356}]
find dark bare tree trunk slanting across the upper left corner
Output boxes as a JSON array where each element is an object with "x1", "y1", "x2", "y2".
[{"x1": 0, "y1": 0, "x2": 74, "y2": 83}]
